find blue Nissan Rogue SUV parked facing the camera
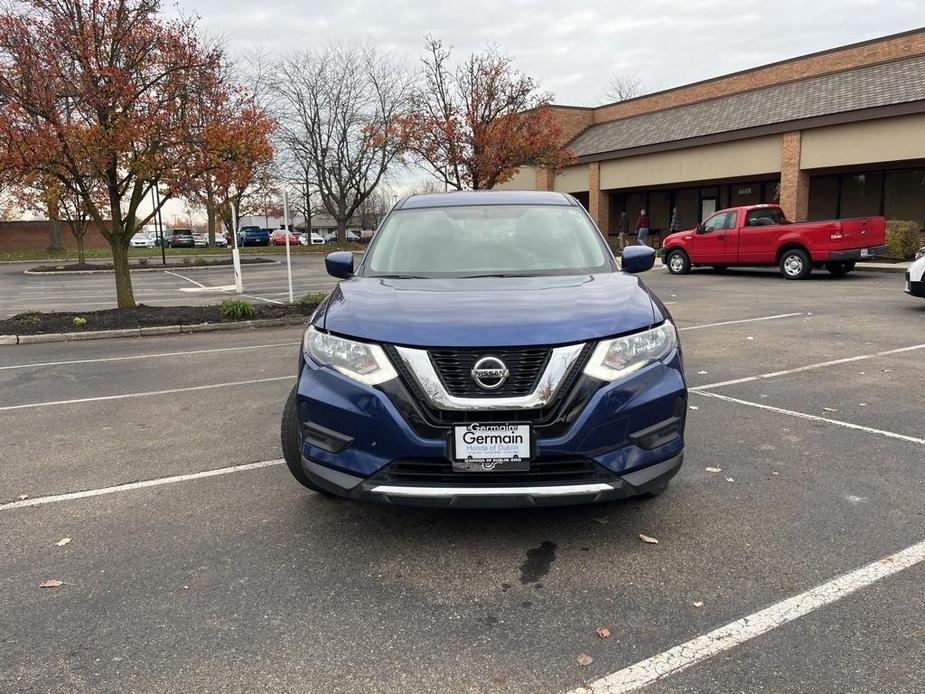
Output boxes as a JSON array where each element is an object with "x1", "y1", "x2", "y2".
[{"x1": 282, "y1": 192, "x2": 687, "y2": 507}]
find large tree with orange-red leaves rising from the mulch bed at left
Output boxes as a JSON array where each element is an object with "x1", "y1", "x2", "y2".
[{"x1": 0, "y1": 0, "x2": 236, "y2": 308}]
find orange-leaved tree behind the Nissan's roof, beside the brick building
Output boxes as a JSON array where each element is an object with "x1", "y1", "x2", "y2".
[{"x1": 404, "y1": 37, "x2": 573, "y2": 190}]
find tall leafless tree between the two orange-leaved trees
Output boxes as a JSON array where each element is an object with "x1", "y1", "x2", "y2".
[{"x1": 274, "y1": 44, "x2": 411, "y2": 241}]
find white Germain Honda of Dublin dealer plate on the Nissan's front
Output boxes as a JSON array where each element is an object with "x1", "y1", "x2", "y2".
[{"x1": 453, "y1": 423, "x2": 532, "y2": 472}]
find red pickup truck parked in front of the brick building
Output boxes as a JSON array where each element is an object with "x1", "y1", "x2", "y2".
[{"x1": 662, "y1": 205, "x2": 887, "y2": 280}]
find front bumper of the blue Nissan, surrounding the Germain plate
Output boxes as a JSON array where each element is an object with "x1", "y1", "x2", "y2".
[{"x1": 297, "y1": 351, "x2": 687, "y2": 507}]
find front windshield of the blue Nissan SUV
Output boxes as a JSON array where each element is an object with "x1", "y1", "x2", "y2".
[{"x1": 363, "y1": 205, "x2": 615, "y2": 277}]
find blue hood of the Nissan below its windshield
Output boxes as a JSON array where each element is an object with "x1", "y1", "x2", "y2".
[{"x1": 316, "y1": 272, "x2": 663, "y2": 347}]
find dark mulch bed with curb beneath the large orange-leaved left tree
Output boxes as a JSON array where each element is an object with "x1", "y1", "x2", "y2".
[{"x1": 0, "y1": 303, "x2": 317, "y2": 335}]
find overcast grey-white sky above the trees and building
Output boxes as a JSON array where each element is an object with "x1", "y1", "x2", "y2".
[{"x1": 182, "y1": 0, "x2": 925, "y2": 105}]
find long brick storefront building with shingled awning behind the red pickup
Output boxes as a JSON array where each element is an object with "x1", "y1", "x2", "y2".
[{"x1": 500, "y1": 29, "x2": 925, "y2": 245}]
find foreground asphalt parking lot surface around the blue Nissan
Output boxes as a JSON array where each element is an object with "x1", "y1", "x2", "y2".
[{"x1": 0, "y1": 268, "x2": 925, "y2": 693}]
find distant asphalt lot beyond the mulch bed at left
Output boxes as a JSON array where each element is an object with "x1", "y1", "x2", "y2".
[{"x1": 0, "y1": 253, "x2": 337, "y2": 320}]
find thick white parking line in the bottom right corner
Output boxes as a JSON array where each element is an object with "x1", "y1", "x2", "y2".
[{"x1": 570, "y1": 541, "x2": 925, "y2": 694}]
